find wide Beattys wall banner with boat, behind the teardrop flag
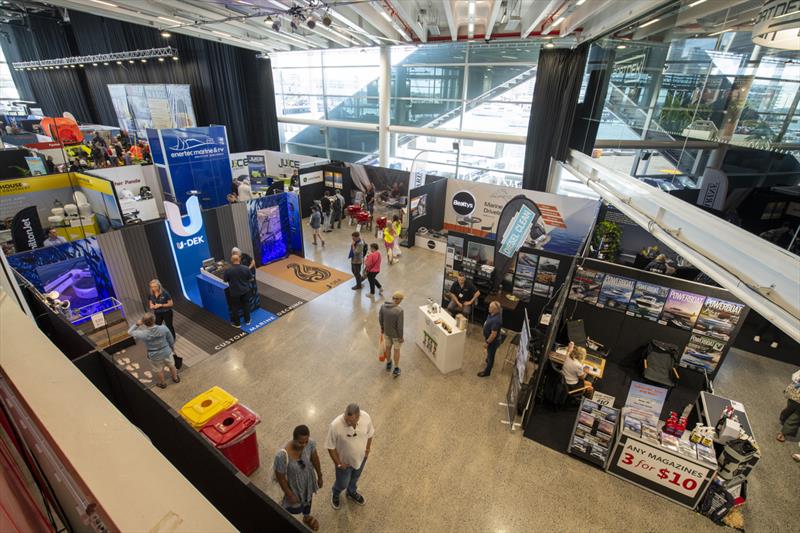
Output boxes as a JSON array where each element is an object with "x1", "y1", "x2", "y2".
[{"x1": 444, "y1": 179, "x2": 600, "y2": 255}]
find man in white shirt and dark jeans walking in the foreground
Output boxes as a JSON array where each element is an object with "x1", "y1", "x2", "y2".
[{"x1": 325, "y1": 403, "x2": 375, "y2": 510}]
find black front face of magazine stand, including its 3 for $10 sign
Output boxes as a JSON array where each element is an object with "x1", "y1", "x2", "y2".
[{"x1": 606, "y1": 422, "x2": 717, "y2": 509}]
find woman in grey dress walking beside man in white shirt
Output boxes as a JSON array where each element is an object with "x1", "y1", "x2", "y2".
[{"x1": 272, "y1": 425, "x2": 322, "y2": 531}]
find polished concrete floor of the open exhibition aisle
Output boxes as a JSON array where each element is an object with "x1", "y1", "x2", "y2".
[{"x1": 155, "y1": 228, "x2": 800, "y2": 532}]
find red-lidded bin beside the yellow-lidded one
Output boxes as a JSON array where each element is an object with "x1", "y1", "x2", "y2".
[{"x1": 200, "y1": 404, "x2": 261, "y2": 476}]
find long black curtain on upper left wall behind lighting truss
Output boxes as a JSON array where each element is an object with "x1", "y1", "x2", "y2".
[{"x1": 3, "y1": 11, "x2": 280, "y2": 152}]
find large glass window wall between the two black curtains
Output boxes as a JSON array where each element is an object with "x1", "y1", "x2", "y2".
[{"x1": 272, "y1": 42, "x2": 539, "y2": 185}]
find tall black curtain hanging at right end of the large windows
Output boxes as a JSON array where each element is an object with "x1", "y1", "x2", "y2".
[{"x1": 522, "y1": 45, "x2": 589, "y2": 191}]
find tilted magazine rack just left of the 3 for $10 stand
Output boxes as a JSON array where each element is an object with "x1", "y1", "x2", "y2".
[{"x1": 568, "y1": 398, "x2": 619, "y2": 467}]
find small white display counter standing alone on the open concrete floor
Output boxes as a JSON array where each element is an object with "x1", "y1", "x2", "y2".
[{"x1": 415, "y1": 305, "x2": 467, "y2": 374}]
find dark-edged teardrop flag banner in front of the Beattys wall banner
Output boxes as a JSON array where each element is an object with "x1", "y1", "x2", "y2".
[{"x1": 494, "y1": 194, "x2": 547, "y2": 286}]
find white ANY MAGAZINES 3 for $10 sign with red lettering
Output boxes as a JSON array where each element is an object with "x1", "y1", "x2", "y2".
[{"x1": 616, "y1": 439, "x2": 709, "y2": 498}]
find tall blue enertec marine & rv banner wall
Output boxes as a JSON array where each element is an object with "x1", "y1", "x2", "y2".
[{"x1": 148, "y1": 126, "x2": 233, "y2": 209}]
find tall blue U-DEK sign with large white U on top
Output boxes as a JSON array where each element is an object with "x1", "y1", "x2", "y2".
[{"x1": 164, "y1": 196, "x2": 211, "y2": 307}]
